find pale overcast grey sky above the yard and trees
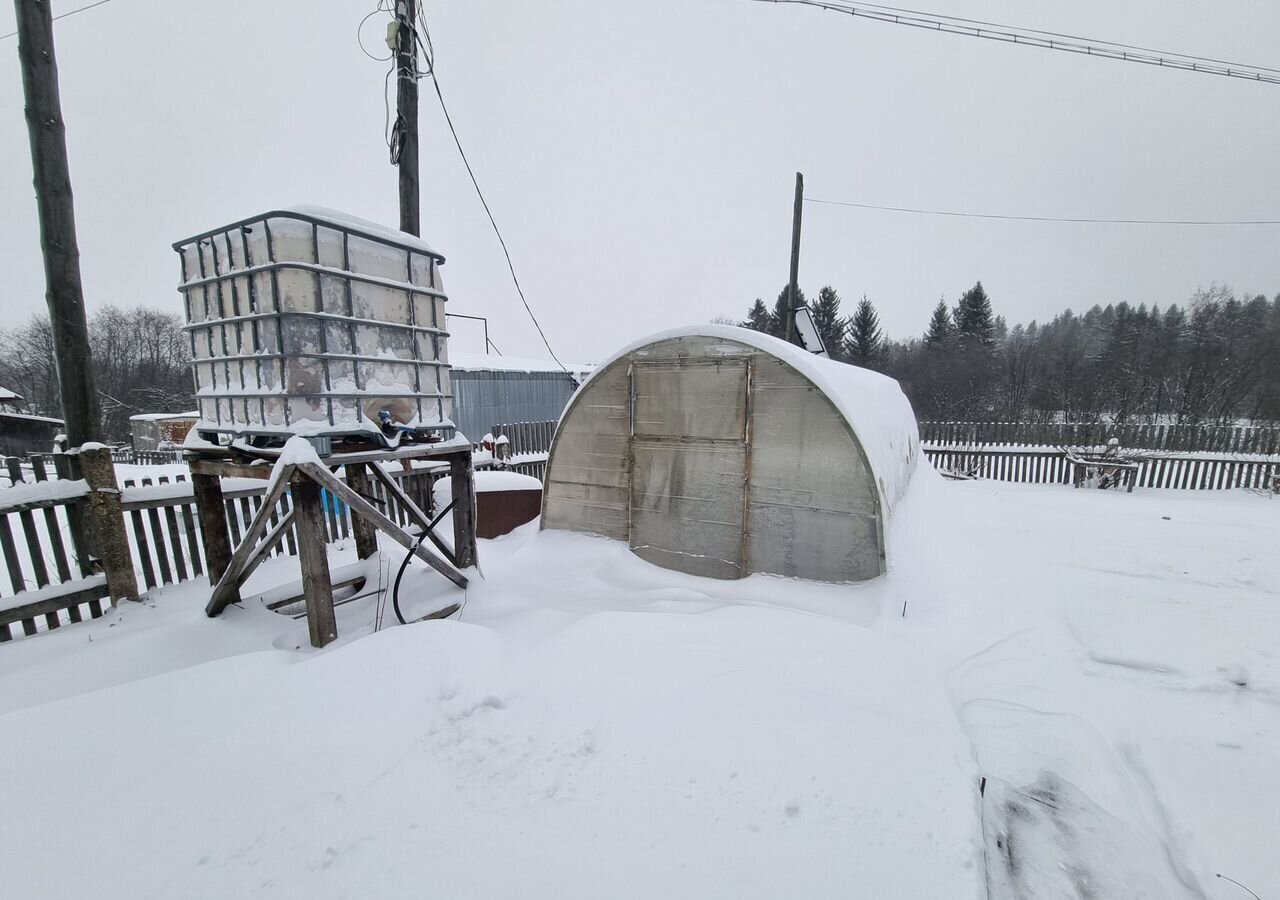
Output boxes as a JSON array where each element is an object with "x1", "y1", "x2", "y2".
[{"x1": 0, "y1": 0, "x2": 1280, "y2": 361}]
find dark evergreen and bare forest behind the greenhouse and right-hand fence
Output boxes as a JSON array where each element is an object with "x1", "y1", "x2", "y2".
[{"x1": 739, "y1": 282, "x2": 1280, "y2": 425}]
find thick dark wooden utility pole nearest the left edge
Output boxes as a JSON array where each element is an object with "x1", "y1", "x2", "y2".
[{"x1": 13, "y1": 0, "x2": 102, "y2": 447}]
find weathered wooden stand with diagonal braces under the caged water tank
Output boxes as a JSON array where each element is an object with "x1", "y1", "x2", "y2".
[{"x1": 188, "y1": 444, "x2": 476, "y2": 647}]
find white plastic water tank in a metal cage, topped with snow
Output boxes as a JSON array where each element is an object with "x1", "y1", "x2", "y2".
[{"x1": 173, "y1": 207, "x2": 453, "y2": 440}]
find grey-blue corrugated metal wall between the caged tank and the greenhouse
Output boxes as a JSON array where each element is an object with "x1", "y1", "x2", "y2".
[{"x1": 449, "y1": 369, "x2": 577, "y2": 442}]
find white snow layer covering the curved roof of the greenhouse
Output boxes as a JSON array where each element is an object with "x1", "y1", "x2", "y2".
[{"x1": 571, "y1": 325, "x2": 920, "y2": 511}]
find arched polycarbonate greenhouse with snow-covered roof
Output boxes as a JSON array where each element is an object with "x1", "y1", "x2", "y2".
[{"x1": 541, "y1": 325, "x2": 920, "y2": 581}]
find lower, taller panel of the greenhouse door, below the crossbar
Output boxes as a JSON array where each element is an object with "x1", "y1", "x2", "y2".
[{"x1": 631, "y1": 439, "x2": 746, "y2": 579}]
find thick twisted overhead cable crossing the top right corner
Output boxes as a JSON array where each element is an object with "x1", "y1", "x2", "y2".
[{"x1": 753, "y1": 0, "x2": 1280, "y2": 84}]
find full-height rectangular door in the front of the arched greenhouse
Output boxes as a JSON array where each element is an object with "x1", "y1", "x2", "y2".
[{"x1": 630, "y1": 360, "x2": 751, "y2": 579}]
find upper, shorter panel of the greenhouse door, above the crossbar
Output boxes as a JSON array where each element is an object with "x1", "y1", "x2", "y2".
[{"x1": 631, "y1": 360, "x2": 748, "y2": 440}]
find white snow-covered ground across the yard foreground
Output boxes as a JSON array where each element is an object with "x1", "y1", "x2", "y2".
[{"x1": 0, "y1": 466, "x2": 1280, "y2": 900}]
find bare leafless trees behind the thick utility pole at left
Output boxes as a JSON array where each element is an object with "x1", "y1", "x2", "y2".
[{"x1": 0, "y1": 306, "x2": 195, "y2": 440}]
